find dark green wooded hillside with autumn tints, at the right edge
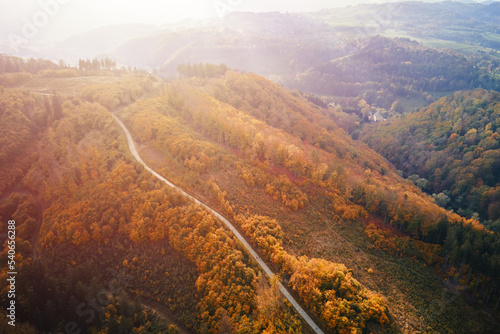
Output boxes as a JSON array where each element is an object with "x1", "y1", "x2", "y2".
[{"x1": 361, "y1": 90, "x2": 500, "y2": 231}]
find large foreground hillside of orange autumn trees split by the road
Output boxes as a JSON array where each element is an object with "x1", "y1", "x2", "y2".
[{"x1": 0, "y1": 58, "x2": 500, "y2": 333}]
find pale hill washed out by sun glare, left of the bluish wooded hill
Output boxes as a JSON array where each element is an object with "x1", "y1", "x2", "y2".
[{"x1": 114, "y1": 13, "x2": 338, "y2": 77}]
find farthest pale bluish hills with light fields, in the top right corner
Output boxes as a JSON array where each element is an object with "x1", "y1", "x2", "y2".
[{"x1": 309, "y1": 1, "x2": 500, "y2": 50}]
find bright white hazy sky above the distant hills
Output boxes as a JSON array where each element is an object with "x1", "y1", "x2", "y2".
[{"x1": 0, "y1": 0, "x2": 408, "y2": 39}]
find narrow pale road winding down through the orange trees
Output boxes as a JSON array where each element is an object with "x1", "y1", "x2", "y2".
[{"x1": 112, "y1": 114, "x2": 324, "y2": 334}]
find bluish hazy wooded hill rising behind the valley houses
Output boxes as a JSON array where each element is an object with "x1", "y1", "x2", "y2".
[{"x1": 290, "y1": 36, "x2": 500, "y2": 111}]
